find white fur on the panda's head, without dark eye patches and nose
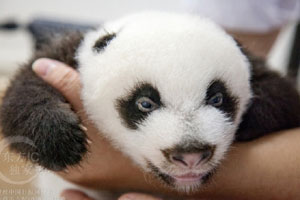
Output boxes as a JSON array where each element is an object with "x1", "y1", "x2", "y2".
[{"x1": 38, "y1": 13, "x2": 251, "y2": 198}]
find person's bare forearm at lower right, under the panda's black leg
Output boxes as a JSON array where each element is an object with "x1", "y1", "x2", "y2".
[{"x1": 197, "y1": 129, "x2": 300, "y2": 199}]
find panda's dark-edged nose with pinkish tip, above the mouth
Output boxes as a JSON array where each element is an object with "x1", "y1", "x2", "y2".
[{"x1": 162, "y1": 145, "x2": 215, "y2": 169}]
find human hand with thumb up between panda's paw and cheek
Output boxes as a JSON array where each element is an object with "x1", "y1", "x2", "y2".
[{"x1": 33, "y1": 58, "x2": 164, "y2": 190}]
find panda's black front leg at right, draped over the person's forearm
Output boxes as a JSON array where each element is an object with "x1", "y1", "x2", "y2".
[{"x1": 236, "y1": 50, "x2": 300, "y2": 141}]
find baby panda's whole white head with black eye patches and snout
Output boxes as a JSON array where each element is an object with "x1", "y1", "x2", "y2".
[{"x1": 77, "y1": 13, "x2": 251, "y2": 191}]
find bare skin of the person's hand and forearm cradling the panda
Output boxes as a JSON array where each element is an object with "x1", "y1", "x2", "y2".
[{"x1": 33, "y1": 59, "x2": 300, "y2": 200}]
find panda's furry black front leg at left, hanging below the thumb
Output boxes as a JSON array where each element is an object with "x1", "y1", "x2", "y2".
[{"x1": 0, "y1": 67, "x2": 87, "y2": 171}]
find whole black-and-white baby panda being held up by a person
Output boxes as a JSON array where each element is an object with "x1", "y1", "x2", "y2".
[{"x1": 1, "y1": 12, "x2": 300, "y2": 198}]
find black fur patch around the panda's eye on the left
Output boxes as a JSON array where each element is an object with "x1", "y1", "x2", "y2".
[{"x1": 116, "y1": 83, "x2": 162, "y2": 129}]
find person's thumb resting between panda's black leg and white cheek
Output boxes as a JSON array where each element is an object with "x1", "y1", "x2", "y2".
[{"x1": 32, "y1": 58, "x2": 82, "y2": 110}]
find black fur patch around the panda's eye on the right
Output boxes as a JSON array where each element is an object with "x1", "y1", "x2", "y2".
[{"x1": 205, "y1": 80, "x2": 238, "y2": 119}]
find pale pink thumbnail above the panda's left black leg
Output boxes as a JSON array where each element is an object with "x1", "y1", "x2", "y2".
[{"x1": 32, "y1": 58, "x2": 57, "y2": 76}]
